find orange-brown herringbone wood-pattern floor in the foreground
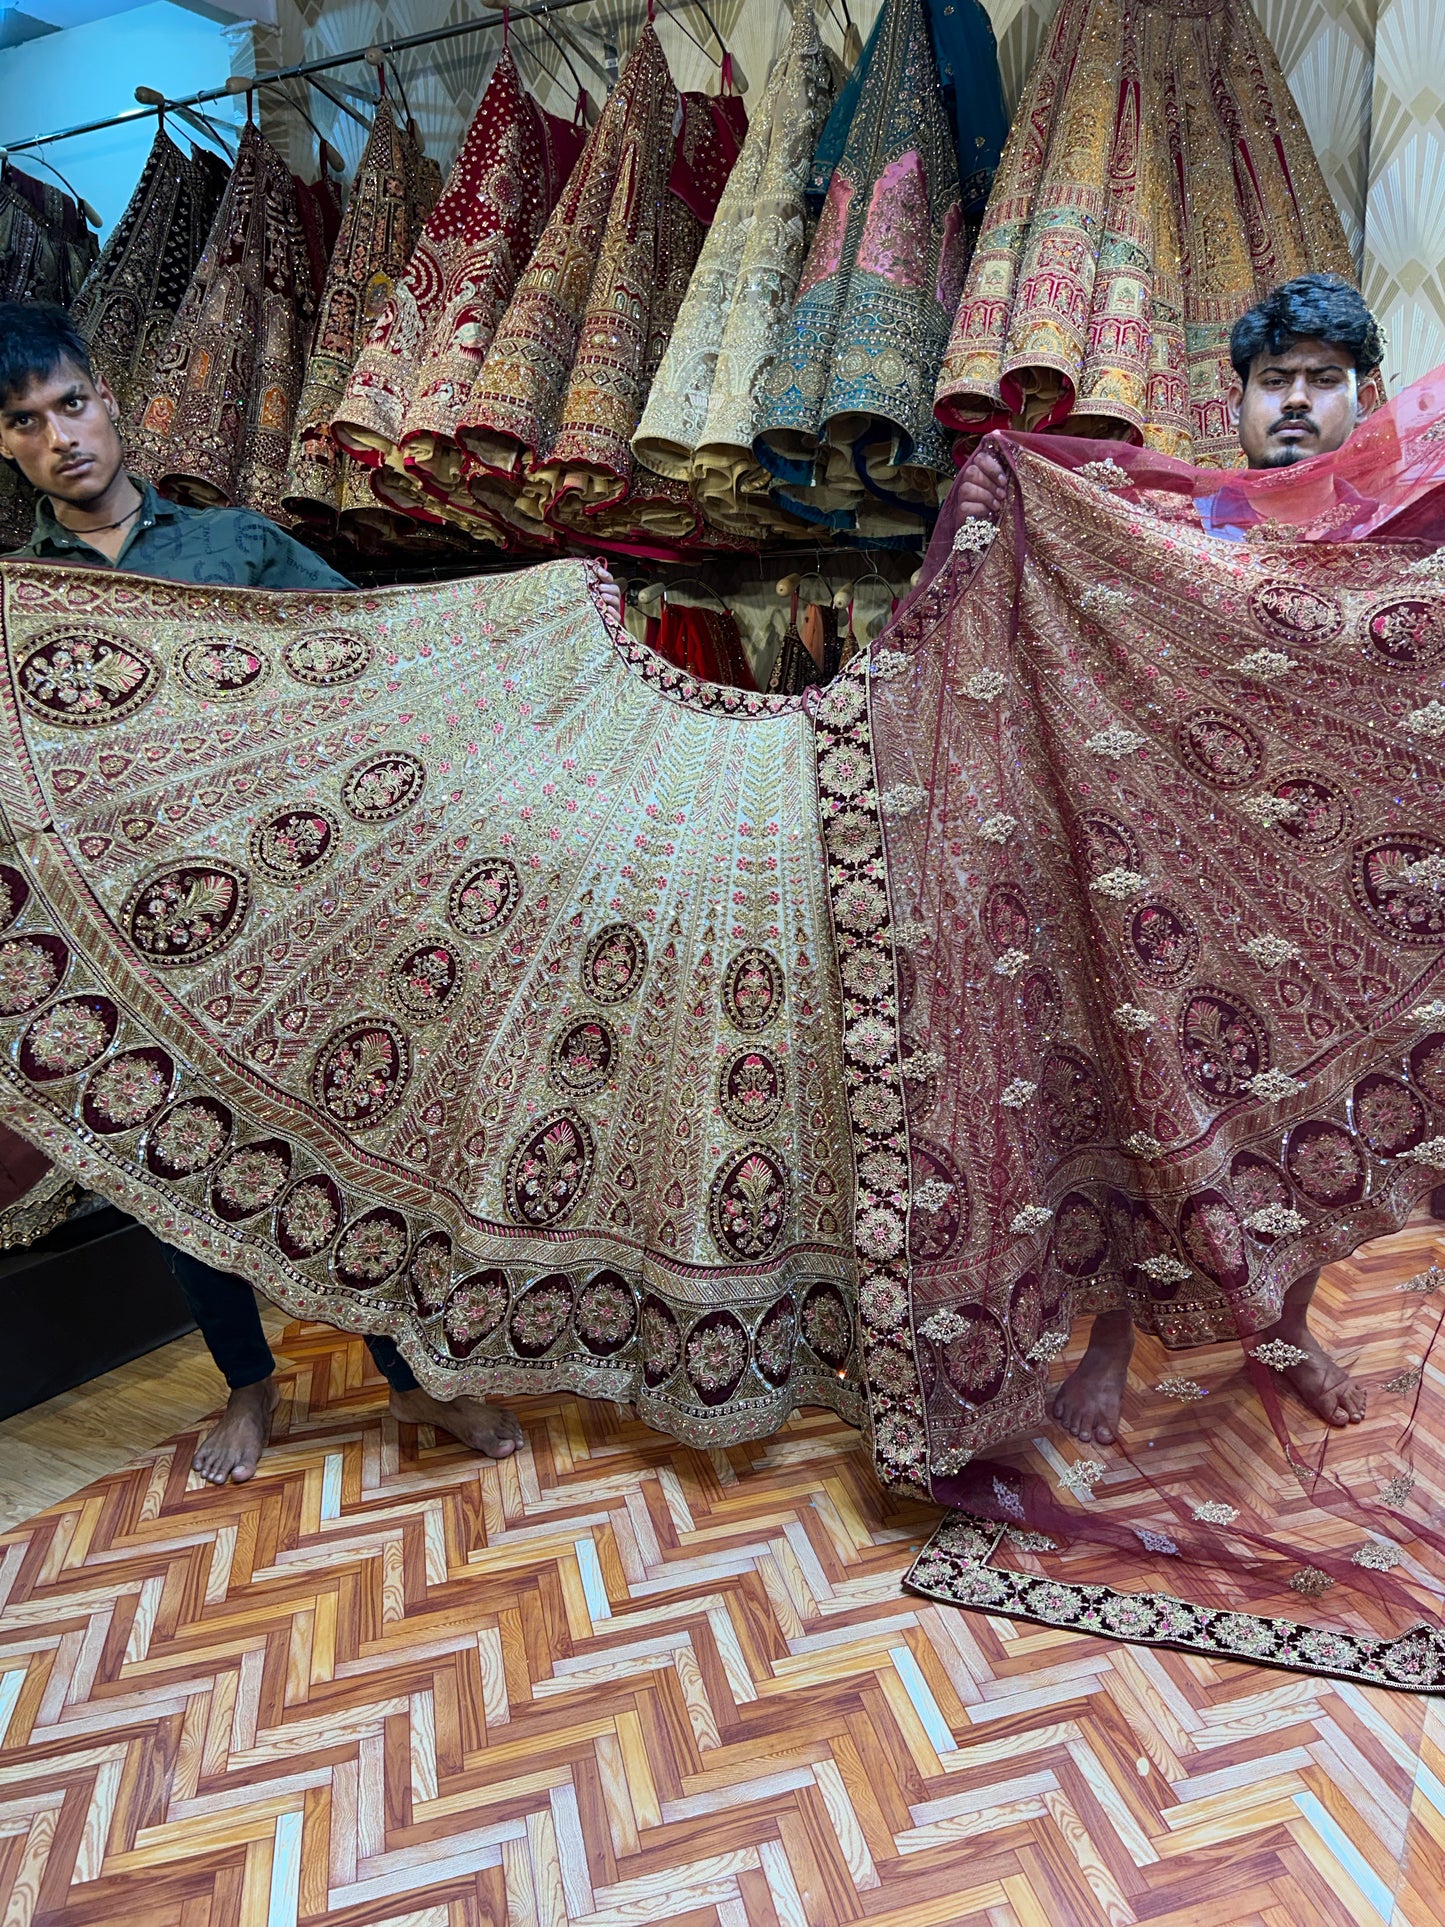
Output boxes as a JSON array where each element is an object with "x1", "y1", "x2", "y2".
[{"x1": 0, "y1": 1226, "x2": 1445, "y2": 1927}]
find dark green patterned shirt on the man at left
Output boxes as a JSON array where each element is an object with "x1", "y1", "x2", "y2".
[{"x1": 8, "y1": 476, "x2": 355, "y2": 590}]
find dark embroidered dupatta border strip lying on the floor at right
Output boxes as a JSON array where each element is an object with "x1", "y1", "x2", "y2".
[{"x1": 904, "y1": 1513, "x2": 1445, "y2": 1694}]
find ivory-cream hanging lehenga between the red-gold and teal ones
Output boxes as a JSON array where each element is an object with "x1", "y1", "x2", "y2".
[{"x1": 632, "y1": 0, "x2": 832, "y2": 536}]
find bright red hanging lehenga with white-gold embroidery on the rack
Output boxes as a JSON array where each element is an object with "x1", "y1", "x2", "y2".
[{"x1": 333, "y1": 50, "x2": 582, "y2": 532}]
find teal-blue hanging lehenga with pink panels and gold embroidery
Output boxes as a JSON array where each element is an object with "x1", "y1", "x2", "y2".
[{"x1": 753, "y1": 0, "x2": 971, "y2": 541}]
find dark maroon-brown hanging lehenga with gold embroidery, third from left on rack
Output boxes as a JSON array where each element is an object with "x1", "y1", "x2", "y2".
[{"x1": 131, "y1": 123, "x2": 316, "y2": 515}]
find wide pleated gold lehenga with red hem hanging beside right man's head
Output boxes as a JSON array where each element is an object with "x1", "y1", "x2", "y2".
[{"x1": 938, "y1": 0, "x2": 1353, "y2": 466}]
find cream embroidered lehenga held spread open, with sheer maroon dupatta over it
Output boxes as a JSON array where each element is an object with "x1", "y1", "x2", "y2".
[{"x1": 0, "y1": 382, "x2": 1445, "y2": 1690}]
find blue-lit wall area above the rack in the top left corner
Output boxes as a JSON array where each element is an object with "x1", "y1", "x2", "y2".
[{"x1": 0, "y1": 0, "x2": 245, "y2": 239}]
